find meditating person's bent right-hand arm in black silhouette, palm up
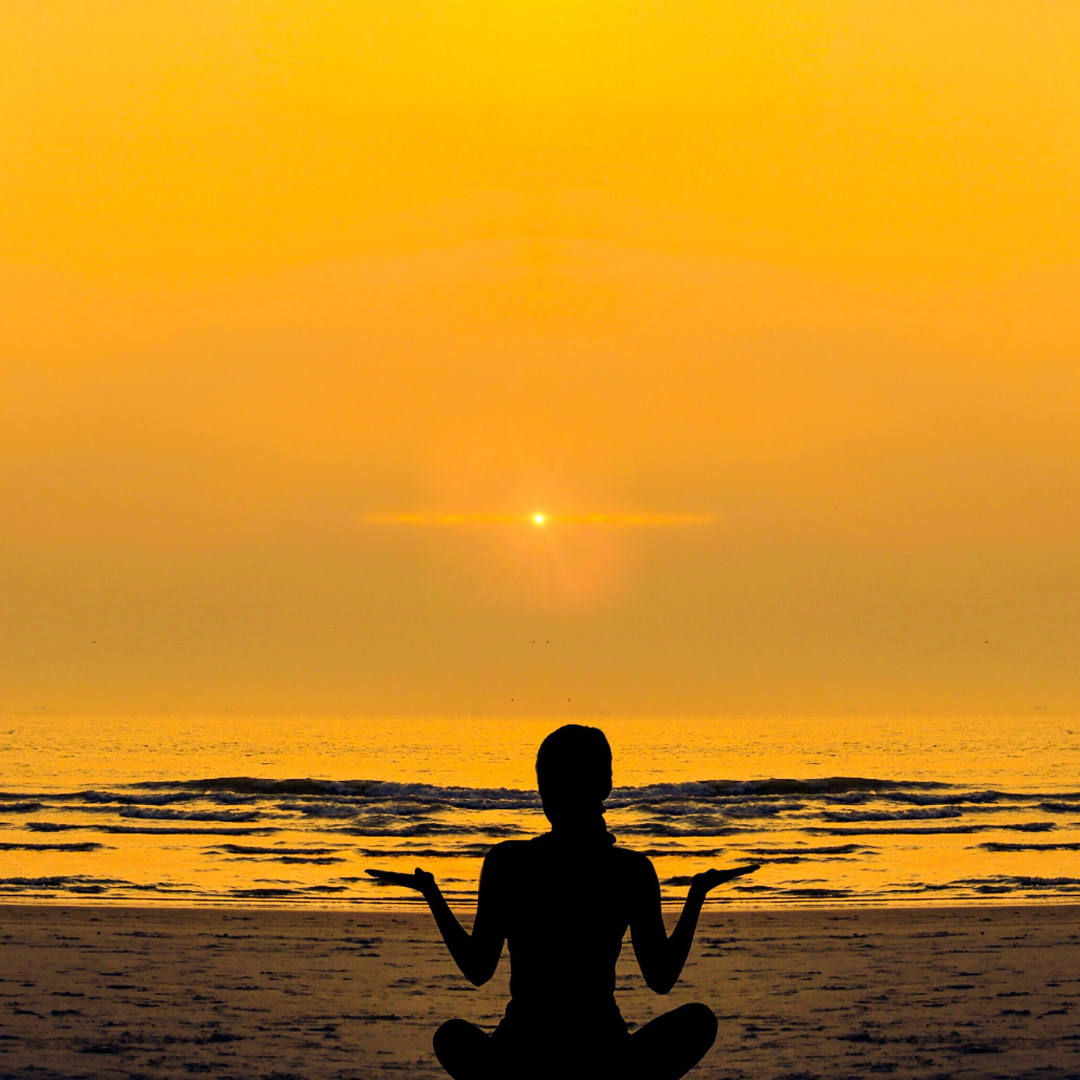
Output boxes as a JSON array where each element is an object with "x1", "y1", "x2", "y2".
[{"x1": 630, "y1": 859, "x2": 757, "y2": 994}]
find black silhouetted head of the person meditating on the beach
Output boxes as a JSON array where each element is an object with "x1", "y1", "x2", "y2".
[{"x1": 537, "y1": 724, "x2": 611, "y2": 828}]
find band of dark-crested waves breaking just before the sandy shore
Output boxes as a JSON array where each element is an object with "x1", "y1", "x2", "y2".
[{"x1": 0, "y1": 777, "x2": 1080, "y2": 905}]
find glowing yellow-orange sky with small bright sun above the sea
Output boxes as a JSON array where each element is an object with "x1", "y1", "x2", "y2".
[{"x1": 0, "y1": 0, "x2": 1080, "y2": 713}]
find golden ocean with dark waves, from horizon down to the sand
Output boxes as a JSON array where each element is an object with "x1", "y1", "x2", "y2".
[{"x1": 0, "y1": 713, "x2": 1080, "y2": 908}]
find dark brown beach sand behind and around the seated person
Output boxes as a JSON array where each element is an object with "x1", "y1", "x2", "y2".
[{"x1": 0, "y1": 905, "x2": 1080, "y2": 1080}]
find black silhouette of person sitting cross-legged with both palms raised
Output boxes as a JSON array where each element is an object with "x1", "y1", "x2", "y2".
[{"x1": 368, "y1": 724, "x2": 757, "y2": 1080}]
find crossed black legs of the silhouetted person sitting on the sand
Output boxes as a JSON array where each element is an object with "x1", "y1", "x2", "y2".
[{"x1": 432, "y1": 1003, "x2": 716, "y2": 1080}]
